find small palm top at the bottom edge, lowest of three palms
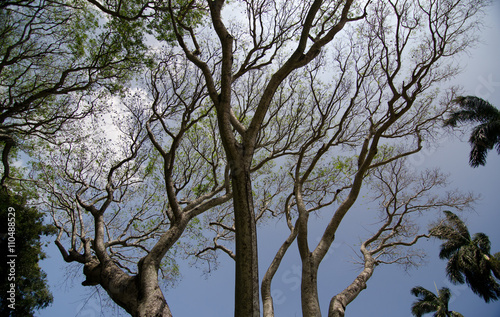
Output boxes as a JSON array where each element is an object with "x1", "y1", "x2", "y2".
[{"x1": 411, "y1": 286, "x2": 463, "y2": 317}]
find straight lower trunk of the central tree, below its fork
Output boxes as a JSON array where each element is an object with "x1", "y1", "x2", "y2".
[{"x1": 232, "y1": 168, "x2": 260, "y2": 317}]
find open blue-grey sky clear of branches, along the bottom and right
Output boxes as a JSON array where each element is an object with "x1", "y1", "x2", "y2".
[{"x1": 36, "y1": 0, "x2": 500, "y2": 317}]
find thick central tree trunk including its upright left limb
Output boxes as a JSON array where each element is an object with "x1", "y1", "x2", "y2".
[{"x1": 205, "y1": 1, "x2": 260, "y2": 308}]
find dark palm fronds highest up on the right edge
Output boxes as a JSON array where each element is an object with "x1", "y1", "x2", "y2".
[{"x1": 444, "y1": 96, "x2": 500, "y2": 167}]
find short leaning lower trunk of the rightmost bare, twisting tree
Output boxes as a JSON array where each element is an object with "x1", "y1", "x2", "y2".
[{"x1": 328, "y1": 254, "x2": 376, "y2": 317}]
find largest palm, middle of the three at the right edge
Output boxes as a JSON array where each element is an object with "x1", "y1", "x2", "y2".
[{"x1": 430, "y1": 211, "x2": 500, "y2": 302}]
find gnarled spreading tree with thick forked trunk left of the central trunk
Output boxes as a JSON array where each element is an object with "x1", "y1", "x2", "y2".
[{"x1": 33, "y1": 54, "x2": 231, "y2": 316}]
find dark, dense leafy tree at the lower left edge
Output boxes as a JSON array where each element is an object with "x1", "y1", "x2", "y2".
[{"x1": 0, "y1": 186, "x2": 55, "y2": 316}]
